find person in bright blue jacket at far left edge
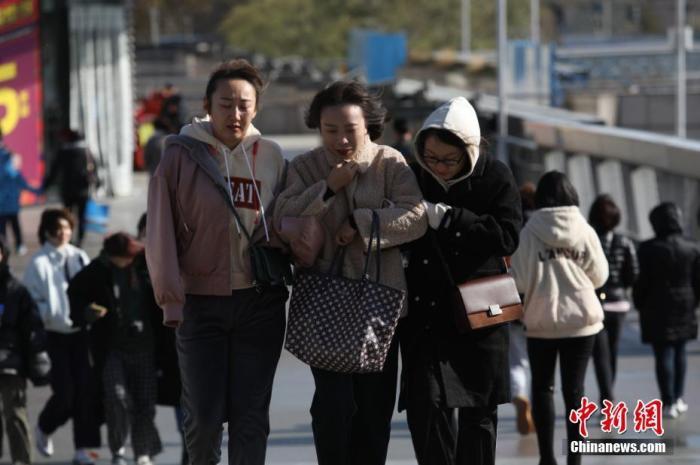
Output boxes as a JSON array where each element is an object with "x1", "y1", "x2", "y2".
[{"x1": 0, "y1": 130, "x2": 41, "y2": 255}]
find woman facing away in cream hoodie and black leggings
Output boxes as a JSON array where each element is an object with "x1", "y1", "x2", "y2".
[{"x1": 511, "y1": 171, "x2": 608, "y2": 465}]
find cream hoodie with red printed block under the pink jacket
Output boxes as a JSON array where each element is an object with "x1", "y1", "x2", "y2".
[{"x1": 180, "y1": 116, "x2": 285, "y2": 289}]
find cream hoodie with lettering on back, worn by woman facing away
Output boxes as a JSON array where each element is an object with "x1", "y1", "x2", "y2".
[{"x1": 511, "y1": 206, "x2": 608, "y2": 339}]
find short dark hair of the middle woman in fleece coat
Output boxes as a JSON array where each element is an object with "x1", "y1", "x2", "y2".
[{"x1": 305, "y1": 81, "x2": 386, "y2": 140}]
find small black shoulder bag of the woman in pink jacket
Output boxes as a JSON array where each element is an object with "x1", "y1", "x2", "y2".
[{"x1": 217, "y1": 184, "x2": 292, "y2": 290}]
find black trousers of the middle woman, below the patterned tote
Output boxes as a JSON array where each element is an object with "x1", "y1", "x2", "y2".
[{"x1": 311, "y1": 338, "x2": 399, "y2": 465}]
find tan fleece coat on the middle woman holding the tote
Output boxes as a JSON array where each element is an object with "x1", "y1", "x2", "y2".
[{"x1": 274, "y1": 141, "x2": 427, "y2": 314}]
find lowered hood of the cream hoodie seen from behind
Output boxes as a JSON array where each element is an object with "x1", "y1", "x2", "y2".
[{"x1": 525, "y1": 206, "x2": 591, "y2": 247}]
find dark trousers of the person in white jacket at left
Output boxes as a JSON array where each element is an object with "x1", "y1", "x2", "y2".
[{"x1": 39, "y1": 331, "x2": 100, "y2": 449}]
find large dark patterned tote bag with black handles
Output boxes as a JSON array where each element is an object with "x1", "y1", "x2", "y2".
[{"x1": 285, "y1": 212, "x2": 406, "y2": 373}]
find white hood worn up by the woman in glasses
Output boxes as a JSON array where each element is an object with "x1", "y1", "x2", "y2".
[{"x1": 414, "y1": 97, "x2": 481, "y2": 189}]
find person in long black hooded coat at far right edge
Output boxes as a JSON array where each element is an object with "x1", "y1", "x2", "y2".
[{"x1": 633, "y1": 202, "x2": 700, "y2": 418}]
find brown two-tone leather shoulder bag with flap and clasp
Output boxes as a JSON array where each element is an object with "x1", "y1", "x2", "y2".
[{"x1": 432, "y1": 230, "x2": 523, "y2": 333}]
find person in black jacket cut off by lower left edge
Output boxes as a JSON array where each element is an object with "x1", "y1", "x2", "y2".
[{"x1": 0, "y1": 237, "x2": 51, "y2": 465}]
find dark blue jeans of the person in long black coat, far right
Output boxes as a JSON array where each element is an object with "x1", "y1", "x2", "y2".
[{"x1": 654, "y1": 341, "x2": 688, "y2": 405}]
